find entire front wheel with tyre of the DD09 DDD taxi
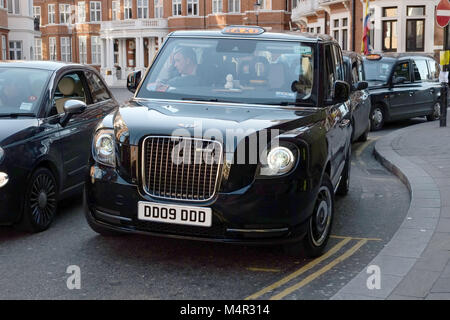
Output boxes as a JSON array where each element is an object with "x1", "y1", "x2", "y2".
[{"x1": 303, "y1": 174, "x2": 334, "y2": 257}]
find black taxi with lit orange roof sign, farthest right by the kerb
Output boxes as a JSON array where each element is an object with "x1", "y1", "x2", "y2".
[{"x1": 364, "y1": 53, "x2": 441, "y2": 130}]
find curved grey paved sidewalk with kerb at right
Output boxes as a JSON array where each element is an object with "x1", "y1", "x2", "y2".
[{"x1": 331, "y1": 113, "x2": 450, "y2": 300}]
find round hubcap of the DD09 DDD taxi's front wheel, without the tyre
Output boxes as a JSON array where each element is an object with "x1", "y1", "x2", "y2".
[{"x1": 310, "y1": 186, "x2": 333, "y2": 246}]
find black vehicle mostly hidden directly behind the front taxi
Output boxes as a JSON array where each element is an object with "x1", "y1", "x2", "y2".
[{"x1": 344, "y1": 51, "x2": 371, "y2": 142}]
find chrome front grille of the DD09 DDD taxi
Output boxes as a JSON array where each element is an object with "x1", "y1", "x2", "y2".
[{"x1": 142, "y1": 136, "x2": 222, "y2": 201}]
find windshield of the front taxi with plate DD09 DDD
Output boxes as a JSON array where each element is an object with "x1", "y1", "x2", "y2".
[{"x1": 137, "y1": 38, "x2": 315, "y2": 105}]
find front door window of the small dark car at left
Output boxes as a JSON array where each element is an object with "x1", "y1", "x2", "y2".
[{"x1": 50, "y1": 72, "x2": 86, "y2": 116}]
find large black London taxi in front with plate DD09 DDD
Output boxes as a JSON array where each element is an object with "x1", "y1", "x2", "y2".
[{"x1": 85, "y1": 26, "x2": 352, "y2": 256}]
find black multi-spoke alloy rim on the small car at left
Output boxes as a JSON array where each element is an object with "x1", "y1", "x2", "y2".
[{"x1": 30, "y1": 174, "x2": 56, "y2": 226}]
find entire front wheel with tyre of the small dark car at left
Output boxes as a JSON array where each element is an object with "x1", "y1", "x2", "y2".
[{"x1": 18, "y1": 168, "x2": 59, "y2": 233}]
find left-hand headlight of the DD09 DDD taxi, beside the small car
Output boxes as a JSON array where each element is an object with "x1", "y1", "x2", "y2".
[{"x1": 92, "y1": 129, "x2": 116, "y2": 167}]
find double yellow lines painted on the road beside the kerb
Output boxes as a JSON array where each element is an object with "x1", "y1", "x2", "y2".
[{"x1": 245, "y1": 237, "x2": 369, "y2": 300}]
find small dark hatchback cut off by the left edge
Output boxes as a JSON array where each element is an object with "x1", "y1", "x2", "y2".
[{"x1": 0, "y1": 61, "x2": 118, "y2": 232}]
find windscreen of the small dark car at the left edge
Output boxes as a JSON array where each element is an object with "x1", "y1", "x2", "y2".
[{"x1": 0, "y1": 68, "x2": 50, "y2": 114}]
